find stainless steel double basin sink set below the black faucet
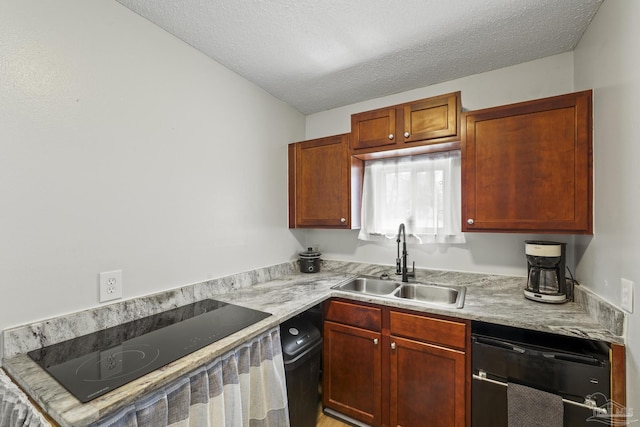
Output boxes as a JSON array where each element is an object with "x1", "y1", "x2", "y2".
[{"x1": 333, "y1": 276, "x2": 467, "y2": 308}]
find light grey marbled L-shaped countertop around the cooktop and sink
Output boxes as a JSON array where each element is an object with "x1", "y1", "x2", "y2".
[{"x1": 3, "y1": 261, "x2": 624, "y2": 426}]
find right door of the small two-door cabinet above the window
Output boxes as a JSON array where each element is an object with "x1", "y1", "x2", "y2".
[{"x1": 400, "y1": 92, "x2": 461, "y2": 143}]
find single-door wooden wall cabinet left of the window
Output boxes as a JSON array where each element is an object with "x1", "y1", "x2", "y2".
[{"x1": 289, "y1": 134, "x2": 363, "y2": 229}]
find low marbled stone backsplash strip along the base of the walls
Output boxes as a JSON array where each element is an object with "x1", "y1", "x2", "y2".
[{"x1": 2, "y1": 260, "x2": 625, "y2": 358}]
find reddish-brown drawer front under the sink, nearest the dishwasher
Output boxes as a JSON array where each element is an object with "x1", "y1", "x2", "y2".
[{"x1": 390, "y1": 311, "x2": 466, "y2": 350}]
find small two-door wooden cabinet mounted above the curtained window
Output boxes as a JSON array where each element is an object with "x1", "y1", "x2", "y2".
[{"x1": 351, "y1": 92, "x2": 461, "y2": 157}]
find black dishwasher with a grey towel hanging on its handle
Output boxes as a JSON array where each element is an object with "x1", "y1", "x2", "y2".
[{"x1": 471, "y1": 322, "x2": 610, "y2": 427}]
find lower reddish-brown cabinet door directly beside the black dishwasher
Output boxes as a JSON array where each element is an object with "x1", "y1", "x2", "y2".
[{"x1": 390, "y1": 336, "x2": 467, "y2": 427}]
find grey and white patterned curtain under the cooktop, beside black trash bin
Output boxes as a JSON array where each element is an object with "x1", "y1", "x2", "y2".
[{"x1": 93, "y1": 327, "x2": 289, "y2": 427}]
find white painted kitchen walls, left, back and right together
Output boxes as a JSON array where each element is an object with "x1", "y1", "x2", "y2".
[{"x1": 0, "y1": 0, "x2": 640, "y2": 412}]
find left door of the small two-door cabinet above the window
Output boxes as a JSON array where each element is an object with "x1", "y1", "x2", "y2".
[{"x1": 351, "y1": 107, "x2": 396, "y2": 152}]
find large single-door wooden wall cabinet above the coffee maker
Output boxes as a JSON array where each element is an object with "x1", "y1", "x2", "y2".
[{"x1": 462, "y1": 91, "x2": 593, "y2": 234}]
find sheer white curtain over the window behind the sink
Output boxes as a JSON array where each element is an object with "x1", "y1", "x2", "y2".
[{"x1": 358, "y1": 151, "x2": 464, "y2": 243}]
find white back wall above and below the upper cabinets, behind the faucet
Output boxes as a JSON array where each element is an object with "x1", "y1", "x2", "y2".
[{"x1": 305, "y1": 52, "x2": 574, "y2": 276}]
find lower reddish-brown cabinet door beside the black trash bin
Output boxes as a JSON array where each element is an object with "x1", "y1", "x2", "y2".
[{"x1": 322, "y1": 321, "x2": 381, "y2": 425}]
